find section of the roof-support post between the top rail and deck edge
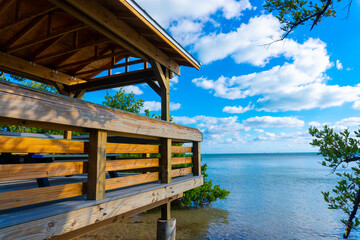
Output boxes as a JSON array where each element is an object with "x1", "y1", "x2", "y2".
[{"x1": 160, "y1": 138, "x2": 172, "y2": 183}]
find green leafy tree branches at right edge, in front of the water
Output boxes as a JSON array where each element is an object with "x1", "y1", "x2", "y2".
[{"x1": 309, "y1": 126, "x2": 360, "y2": 238}]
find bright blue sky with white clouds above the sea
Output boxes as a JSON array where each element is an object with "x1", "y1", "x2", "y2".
[{"x1": 85, "y1": 0, "x2": 360, "y2": 153}]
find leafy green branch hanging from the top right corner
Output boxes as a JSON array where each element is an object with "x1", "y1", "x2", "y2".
[{"x1": 263, "y1": 0, "x2": 352, "y2": 40}]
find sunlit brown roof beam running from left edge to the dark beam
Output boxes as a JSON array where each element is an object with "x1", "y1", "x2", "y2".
[{"x1": 0, "y1": 52, "x2": 85, "y2": 85}]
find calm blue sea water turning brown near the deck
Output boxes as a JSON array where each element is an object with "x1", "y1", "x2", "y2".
[{"x1": 77, "y1": 154, "x2": 360, "y2": 239}]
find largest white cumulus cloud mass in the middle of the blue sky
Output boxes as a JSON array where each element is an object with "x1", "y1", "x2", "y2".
[{"x1": 193, "y1": 15, "x2": 360, "y2": 112}]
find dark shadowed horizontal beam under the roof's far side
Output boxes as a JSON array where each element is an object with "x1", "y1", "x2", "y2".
[{"x1": 68, "y1": 69, "x2": 154, "y2": 92}]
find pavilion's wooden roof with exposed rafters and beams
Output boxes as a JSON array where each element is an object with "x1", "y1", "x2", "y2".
[{"x1": 0, "y1": 0, "x2": 200, "y2": 92}]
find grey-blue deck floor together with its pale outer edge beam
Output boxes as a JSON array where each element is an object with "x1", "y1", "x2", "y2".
[{"x1": 0, "y1": 175, "x2": 203, "y2": 239}]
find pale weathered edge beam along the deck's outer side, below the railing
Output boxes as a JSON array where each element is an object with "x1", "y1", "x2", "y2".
[{"x1": 0, "y1": 177, "x2": 203, "y2": 239}]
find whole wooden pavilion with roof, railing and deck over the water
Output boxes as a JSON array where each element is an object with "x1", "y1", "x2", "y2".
[{"x1": 0, "y1": 0, "x2": 203, "y2": 239}]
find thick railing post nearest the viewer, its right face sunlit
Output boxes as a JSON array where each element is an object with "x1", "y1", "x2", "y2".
[{"x1": 87, "y1": 130, "x2": 107, "y2": 200}]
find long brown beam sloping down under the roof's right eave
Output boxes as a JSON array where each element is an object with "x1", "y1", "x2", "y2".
[{"x1": 51, "y1": 0, "x2": 180, "y2": 75}]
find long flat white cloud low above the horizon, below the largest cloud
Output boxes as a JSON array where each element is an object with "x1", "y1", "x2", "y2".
[{"x1": 243, "y1": 116, "x2": 304, "y2": 128}]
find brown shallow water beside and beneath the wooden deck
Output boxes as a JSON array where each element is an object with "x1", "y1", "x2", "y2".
[{"x1": 77, "y1": 207, "x2": 229, "y2": 240}]
